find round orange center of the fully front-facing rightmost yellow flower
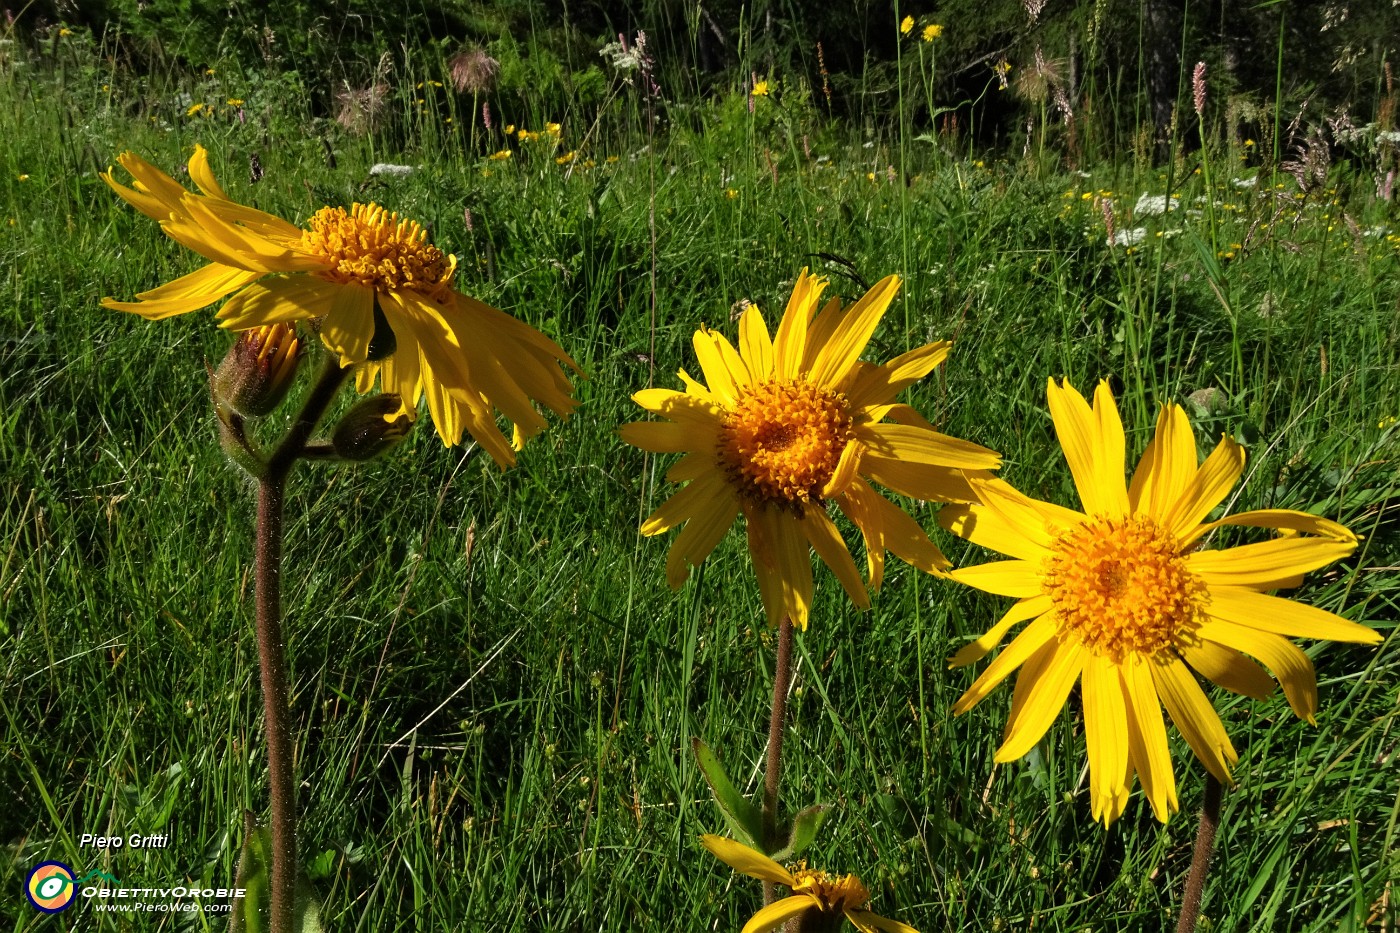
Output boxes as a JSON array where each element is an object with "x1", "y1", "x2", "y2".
[{"x1": 1043, "y1": 516, "x2": 1210, "y2": 664}]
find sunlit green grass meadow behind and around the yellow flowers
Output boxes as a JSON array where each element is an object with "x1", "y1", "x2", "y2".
[{"x1": 0, "y1": 16, "x2": 1400, "y2": 933}]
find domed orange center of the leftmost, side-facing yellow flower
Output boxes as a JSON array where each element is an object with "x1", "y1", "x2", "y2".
[{"x1": 301, "y1": 205, "x2": 456, "y2": 294}]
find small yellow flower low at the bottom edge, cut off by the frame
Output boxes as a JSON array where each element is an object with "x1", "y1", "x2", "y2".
[{"x1": 700, "y1": 835, "x2": 918, "y2": 933}]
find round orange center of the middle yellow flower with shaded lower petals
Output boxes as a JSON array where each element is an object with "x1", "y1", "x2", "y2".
[{"x1": 718, "y1": 380, "x2": 853, "y2": 506}]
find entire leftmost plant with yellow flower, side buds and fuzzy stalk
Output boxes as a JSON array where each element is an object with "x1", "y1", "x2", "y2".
[{"x1": 102, "y1": 147, "x2": 578, "y2": 933}]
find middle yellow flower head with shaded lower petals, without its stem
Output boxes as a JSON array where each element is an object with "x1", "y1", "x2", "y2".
[{"x1": 622, "y1": 269, "x2": 1001, "y2": 629}]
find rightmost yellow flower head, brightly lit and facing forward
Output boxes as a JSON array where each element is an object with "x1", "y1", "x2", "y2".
[{"x1": 939, "y1": 380, "x2": 1380, "y2": 825}]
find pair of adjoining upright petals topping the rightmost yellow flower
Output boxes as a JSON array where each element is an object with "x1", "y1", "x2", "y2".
[{"x1": 1046, "y1": 380, "x2": 1128, "y2": 516}]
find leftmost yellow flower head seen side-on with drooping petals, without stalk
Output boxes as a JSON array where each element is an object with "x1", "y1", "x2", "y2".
[{"x1": 102, "y1": 146, "x2": 581, "y2": 467}]
